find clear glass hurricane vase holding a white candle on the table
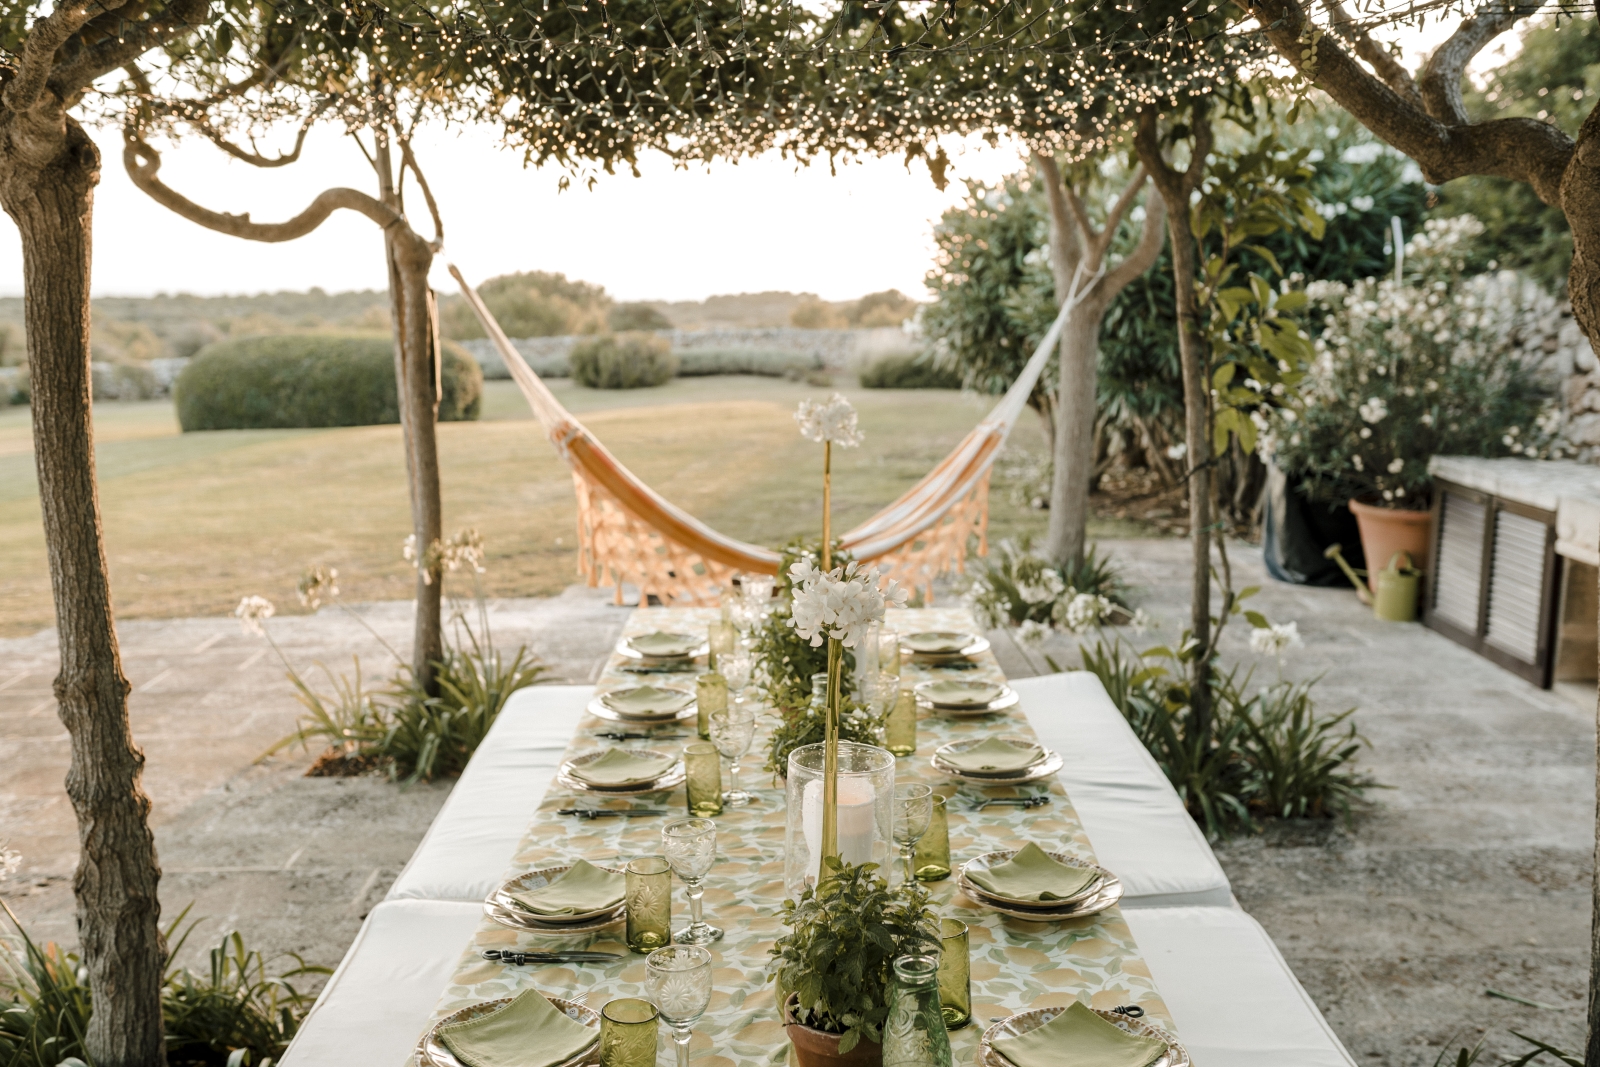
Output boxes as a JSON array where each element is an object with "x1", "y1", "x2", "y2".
[{"x1": 784, "y1": 741, "x2": 894, "y2": 901}]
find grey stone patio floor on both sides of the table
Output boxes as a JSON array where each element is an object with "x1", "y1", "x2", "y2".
[{"x1": 0, "y1": 541, "x2": 1595, "y2": 1067}]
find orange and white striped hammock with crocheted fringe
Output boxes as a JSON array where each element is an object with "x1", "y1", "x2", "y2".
[{"x1": 450, "y1": 264, "x2": 1088, "y2": 605}]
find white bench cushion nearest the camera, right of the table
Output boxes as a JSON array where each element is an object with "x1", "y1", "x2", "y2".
[{"x1": 1123, "y1": 907, "x2": 1355, "y2": 1067}]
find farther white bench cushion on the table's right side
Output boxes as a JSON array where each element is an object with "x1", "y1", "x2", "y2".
[{"x1": 1011, "y1": 670, "x2": 1234, "y2": 909}]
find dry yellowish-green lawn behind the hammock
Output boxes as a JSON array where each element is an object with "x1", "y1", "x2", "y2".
[{"x1": 0, "y1": 378, "x2": 1139, "y2": 635}]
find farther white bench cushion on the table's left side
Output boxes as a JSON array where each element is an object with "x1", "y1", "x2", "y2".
[{"x1": 384, "y1": 685, "x2": 594, "y2": 901}]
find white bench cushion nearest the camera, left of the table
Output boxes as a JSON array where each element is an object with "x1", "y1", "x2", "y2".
[{"x1": 282, "y1": 901, "x2": 483, "y2": 1067}]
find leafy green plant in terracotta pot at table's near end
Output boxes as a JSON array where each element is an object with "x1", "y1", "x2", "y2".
[{"x1": 771, "y1": 857, "x2": 939, "y2": 1067}]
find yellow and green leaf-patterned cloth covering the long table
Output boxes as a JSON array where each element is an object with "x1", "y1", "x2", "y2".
[{"x1": 412, "y1": 608, "x2": 1176, "y2": 1067}]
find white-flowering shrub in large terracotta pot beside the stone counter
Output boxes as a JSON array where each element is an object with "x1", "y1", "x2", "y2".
[{"x1": 1261, "y1": 216, "x2": 1560, "y2": 587}]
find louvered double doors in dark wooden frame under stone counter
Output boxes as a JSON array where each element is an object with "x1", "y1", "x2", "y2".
[{"x1": 1422, "y1": 480, "x2": 1565, "y2": 688}]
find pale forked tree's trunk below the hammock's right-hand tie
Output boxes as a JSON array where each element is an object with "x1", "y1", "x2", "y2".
[{"x1": 1045, "y1": 303, "x2": 1106, "y2": 569}]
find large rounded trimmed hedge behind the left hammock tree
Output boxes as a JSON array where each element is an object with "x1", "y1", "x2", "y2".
[{"x1": 173, "y1": 333, "x2": 483, "y2": 432}]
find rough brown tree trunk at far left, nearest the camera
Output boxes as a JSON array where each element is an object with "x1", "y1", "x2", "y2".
[{"x1": 0, "y1": 120, "x2": 166, "y2": 1067}]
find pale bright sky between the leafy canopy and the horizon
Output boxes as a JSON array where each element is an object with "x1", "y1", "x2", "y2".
[{"x1": 0, "y1": 128, "x2": 1022, "y2": 301}]
